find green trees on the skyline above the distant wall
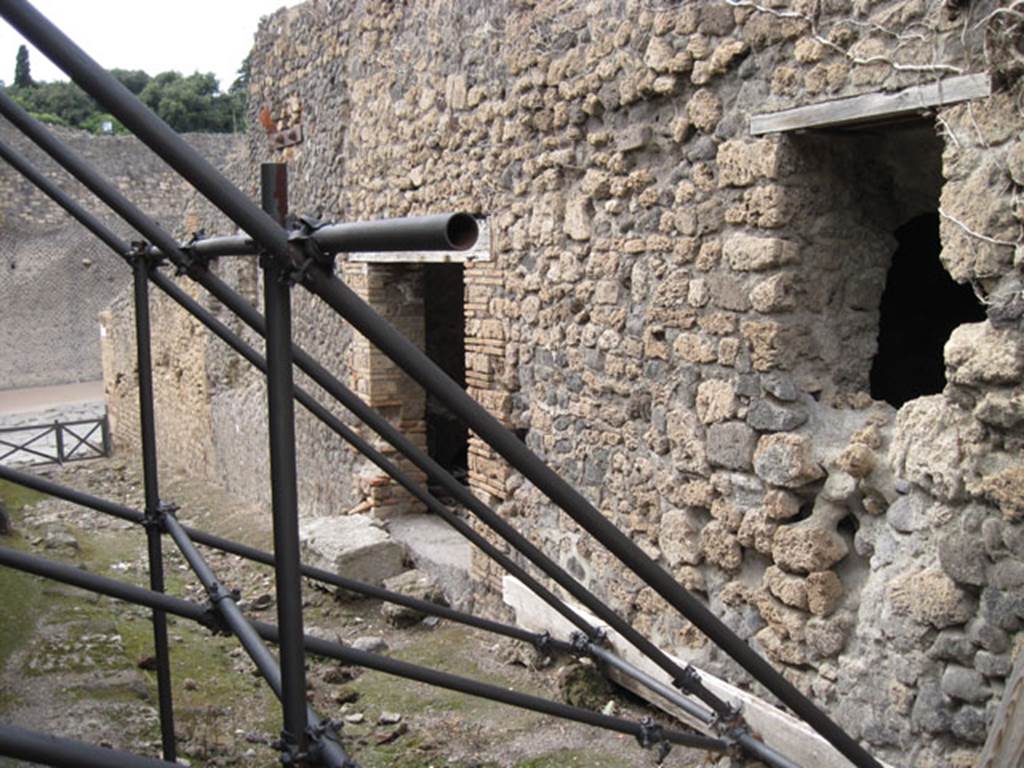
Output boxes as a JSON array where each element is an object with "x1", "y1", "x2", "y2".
[{"x1": 4, "y1": 45, "x2": 249, "y2": 133}]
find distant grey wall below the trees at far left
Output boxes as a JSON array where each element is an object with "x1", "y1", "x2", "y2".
[{"x1": 0, "y1": 123, "x2": 240, "y2": 389}]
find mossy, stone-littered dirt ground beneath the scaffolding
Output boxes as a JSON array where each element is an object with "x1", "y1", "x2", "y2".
[{"x1": 0, "y1": 459, "x2": 729, "y2": 768}]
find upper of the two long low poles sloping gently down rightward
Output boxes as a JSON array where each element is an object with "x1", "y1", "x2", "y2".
[{"x1": 0, "y1": 466, "x2": 571, "y2": 653}]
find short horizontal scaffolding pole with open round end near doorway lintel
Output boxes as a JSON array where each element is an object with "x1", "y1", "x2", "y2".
[{"x1": 146, "y1": 213, "x2": 479, "y2": 259}]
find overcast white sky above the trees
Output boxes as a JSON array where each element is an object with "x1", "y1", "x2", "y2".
[{"x1": 0, "y1": 0, "x2": 301, "y2": 91}]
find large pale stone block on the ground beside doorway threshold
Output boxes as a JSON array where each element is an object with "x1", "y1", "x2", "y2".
[{"x1": 300, "y1": 514, "x2": 404, "y2": 585}]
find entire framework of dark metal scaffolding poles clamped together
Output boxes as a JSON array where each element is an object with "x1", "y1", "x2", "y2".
[{"x1": 0, "y1": 0, "x2": 879, "y2": 768}]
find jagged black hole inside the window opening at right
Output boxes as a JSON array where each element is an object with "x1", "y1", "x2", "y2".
[{"x1": 871, "y1": 213, "x2": 985, "y2": 408}]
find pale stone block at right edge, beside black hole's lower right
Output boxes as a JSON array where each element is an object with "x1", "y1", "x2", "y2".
[{"x1": 944, "y1": 322, "x2": 1024, "y2": 386}]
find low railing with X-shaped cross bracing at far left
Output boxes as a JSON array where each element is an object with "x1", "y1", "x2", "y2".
[{"x1": 0, "y1": 414, "x2": 111, "y2": 464}]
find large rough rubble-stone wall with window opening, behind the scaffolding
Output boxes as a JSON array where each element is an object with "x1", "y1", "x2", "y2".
[{"x1": 99, "y1": 0, "x2": 1024, "y2": 766}]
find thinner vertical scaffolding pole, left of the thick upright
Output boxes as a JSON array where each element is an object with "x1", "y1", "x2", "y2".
[{"x1": 132, "y1": 255, "x2": 177, "y2": 763}]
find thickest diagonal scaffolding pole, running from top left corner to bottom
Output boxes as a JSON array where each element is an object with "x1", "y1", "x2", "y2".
[{"x1": 0, "y1": 6, "x2": 880, "y2": 768}]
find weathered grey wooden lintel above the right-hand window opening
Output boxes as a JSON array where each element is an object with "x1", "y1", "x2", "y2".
[{"x1": 751, "y1": 73, "x2": 992, "y2": 136}]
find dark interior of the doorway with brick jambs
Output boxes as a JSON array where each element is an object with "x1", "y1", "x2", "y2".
[{"x1": 423, "y1": 264, "x2": 469, "y2": 496}]
